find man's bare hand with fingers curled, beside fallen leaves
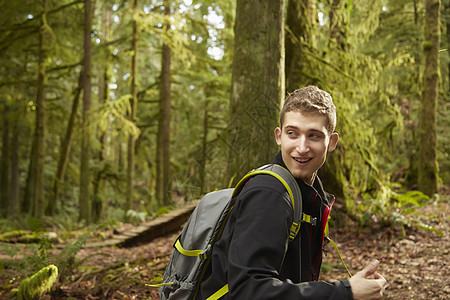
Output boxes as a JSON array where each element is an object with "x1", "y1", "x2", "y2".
[{"x1": 349, "y1": 260, "x2": 386, "y2": 300}]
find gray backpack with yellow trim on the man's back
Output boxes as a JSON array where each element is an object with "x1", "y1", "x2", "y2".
[{"x1": 152, "y1": 164, "x2": 302, "y2": 300}]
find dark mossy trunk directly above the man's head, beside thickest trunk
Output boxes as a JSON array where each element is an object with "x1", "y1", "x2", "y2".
[{"x1": 286, "y1": 0, "x2": 317, "y2": 92}]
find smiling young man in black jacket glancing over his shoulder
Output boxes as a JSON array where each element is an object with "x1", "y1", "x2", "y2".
[{"x1": 199, "y1": 86, "x2": 386, "y2": 300}]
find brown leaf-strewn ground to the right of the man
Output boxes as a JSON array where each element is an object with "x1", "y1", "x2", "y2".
[{"x1": 322, "y1": 202, "x2": 450, "y2": 300}]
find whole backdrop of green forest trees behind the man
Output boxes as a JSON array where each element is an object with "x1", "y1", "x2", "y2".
[{"x1": 0, "y1": 0, "x2": 450, "y2": 229}]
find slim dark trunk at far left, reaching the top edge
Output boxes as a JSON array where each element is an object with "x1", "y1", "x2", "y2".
[{"x1": 31, "y1": 0, "x2": 47, "y2": 218}]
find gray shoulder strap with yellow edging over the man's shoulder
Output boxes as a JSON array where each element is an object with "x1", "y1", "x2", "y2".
[{"x1": 233, "y1": 164, "x2": 302, "y2": 241}]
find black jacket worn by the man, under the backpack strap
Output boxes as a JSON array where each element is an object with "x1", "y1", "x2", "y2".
[{"x1": 198, "y1": 153, "x2": 353, "y2": 300}]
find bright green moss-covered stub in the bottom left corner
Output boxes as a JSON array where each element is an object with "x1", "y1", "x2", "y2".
[{"x1": 11, "y1": 265, "x2": 58, "y2": 300}]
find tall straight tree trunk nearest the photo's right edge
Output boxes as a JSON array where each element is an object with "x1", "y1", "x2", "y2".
[{"x1": 419, "y1": 0, "x2": 441, "y2": 196}]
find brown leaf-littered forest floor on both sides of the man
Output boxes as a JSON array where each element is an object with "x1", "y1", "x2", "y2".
[{"x1": 0, "y1": 201, "x2": 450, "y2": 300}]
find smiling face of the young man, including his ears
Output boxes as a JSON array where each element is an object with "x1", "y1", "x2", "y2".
[{"x1": 275, "y1": 111, "x2": 339, "y2": 185}]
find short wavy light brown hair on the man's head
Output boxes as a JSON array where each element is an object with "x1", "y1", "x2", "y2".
[{"x1": 280, "y1": 85, "x2": 336, "y2": 134}]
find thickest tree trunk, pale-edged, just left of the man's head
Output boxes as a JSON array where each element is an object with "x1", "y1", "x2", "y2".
[{"x1": 224, "y1": 0, "x2": 284, "y2": 183}]
